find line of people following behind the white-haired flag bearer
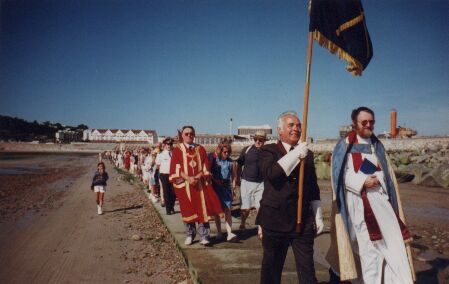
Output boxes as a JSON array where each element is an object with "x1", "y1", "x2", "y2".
[{"x1": 100, "y1": 131, "x2": 267, "y2": 246}]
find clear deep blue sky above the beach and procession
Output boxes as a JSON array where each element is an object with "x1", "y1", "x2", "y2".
[{"x1": 0, "y1": 0, "x2": 449, "y2": 138}]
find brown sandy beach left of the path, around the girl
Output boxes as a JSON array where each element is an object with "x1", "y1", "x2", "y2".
[{"x1": 0, "y1": 154, "x2": 190, "y2": 283}]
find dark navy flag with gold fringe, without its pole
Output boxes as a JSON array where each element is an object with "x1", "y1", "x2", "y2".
[{"x1": 309, "y1": 0, "x2": 373, "y2": 76}]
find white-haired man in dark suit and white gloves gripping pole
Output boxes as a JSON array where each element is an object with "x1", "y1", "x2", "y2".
[{"x1": 256, "y1": 111, "x2": 324, "y2": 284}]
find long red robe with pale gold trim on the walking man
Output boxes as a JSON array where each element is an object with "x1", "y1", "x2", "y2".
[{"x1": 170, "y1": 143, "x2": 223, "y2": 223}]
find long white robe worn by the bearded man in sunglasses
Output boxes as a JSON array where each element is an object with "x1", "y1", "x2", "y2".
[{"x1": 345, "y1": 135, "x2": 413, "y2": 284}]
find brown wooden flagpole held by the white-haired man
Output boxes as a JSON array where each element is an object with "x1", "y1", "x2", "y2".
[{"x1": 296, "y1": 32, "x2": 313, "y2": 233}]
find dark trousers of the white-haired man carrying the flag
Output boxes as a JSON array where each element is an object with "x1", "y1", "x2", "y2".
[{"x1": 260, "y1": 216, "x2": 317, "y2": 284}]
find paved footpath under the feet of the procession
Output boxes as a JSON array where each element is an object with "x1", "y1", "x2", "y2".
[{"x1": 142, "y1": 187, "x2": 330, "y2": 284}]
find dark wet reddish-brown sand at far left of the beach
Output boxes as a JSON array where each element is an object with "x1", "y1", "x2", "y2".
[{"x1": 0, "y1": 153, "x2": 93, "y2": 223}]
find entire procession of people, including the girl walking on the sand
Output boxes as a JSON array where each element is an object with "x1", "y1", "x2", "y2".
[{"x1": 93, "y1": 107, "x2": 414, "y2": 284}]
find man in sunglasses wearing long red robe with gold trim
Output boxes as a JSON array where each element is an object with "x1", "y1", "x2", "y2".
[{"x1": 170, "y1": 126, "x2": 223, "y2": 246}]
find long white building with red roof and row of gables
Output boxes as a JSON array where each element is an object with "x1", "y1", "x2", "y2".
[{"x1": 87, "y1": 129, "x2": 158, "y2": 144}]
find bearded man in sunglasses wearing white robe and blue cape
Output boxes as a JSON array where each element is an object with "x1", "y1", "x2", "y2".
[{"x1": 327, "y1": 106, "x2": 414, "y2": 283}]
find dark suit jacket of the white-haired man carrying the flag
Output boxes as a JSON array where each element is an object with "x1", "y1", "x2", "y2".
[{"x1": 256, "y1": 141, "x2": 320, "y2": 233}]
